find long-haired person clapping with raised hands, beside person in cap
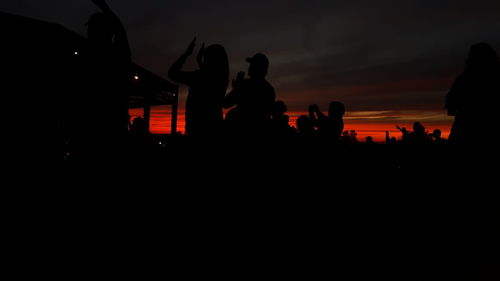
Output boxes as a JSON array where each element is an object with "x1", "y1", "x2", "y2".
[{"x1": 168, "y1": 38, "x2": 229, "y2": 136}]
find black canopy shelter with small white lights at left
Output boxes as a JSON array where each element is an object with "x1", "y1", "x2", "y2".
[{"x1": 0, "y1": 12, "x2": 178, "y2": 136}]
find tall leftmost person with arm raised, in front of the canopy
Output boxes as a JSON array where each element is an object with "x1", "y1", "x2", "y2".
[{"x1": 71, "y1": 0, "x2": 131, "y2": 156}]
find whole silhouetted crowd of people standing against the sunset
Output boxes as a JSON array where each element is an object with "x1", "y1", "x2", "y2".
[{"x1": 56, "y1": 0, "x2": 500, "y2": 163}]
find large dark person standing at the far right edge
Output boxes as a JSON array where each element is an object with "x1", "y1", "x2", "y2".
[{"x1": 445, "y1": 43, "x2": 500, "y2": 145}]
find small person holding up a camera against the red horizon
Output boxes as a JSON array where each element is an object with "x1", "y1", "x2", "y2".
[{"x1": 309, "y1": 101, "x2": 345, "y2": 143}]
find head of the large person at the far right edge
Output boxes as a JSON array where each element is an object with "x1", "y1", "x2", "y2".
[{"x1": 467, "y1": 42, "x2": 499, "y2": 72}]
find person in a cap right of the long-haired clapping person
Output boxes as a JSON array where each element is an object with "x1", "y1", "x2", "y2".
[{"x1": 223, "y1": 53, "x2": 276, "y2": 135}]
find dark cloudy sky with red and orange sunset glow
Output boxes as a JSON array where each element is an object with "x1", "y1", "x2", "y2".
[{"x1": 0, "y1": 0, "x2": 500, "y2": 139}]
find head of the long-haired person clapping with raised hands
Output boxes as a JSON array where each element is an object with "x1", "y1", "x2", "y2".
[{"x1": 200, "y1": 44, "x2": 229, "y2": 87}]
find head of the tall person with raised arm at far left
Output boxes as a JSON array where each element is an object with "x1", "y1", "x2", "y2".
[{"x1": 87, "y1": 13, "x2": 114, "y2": 45}]
